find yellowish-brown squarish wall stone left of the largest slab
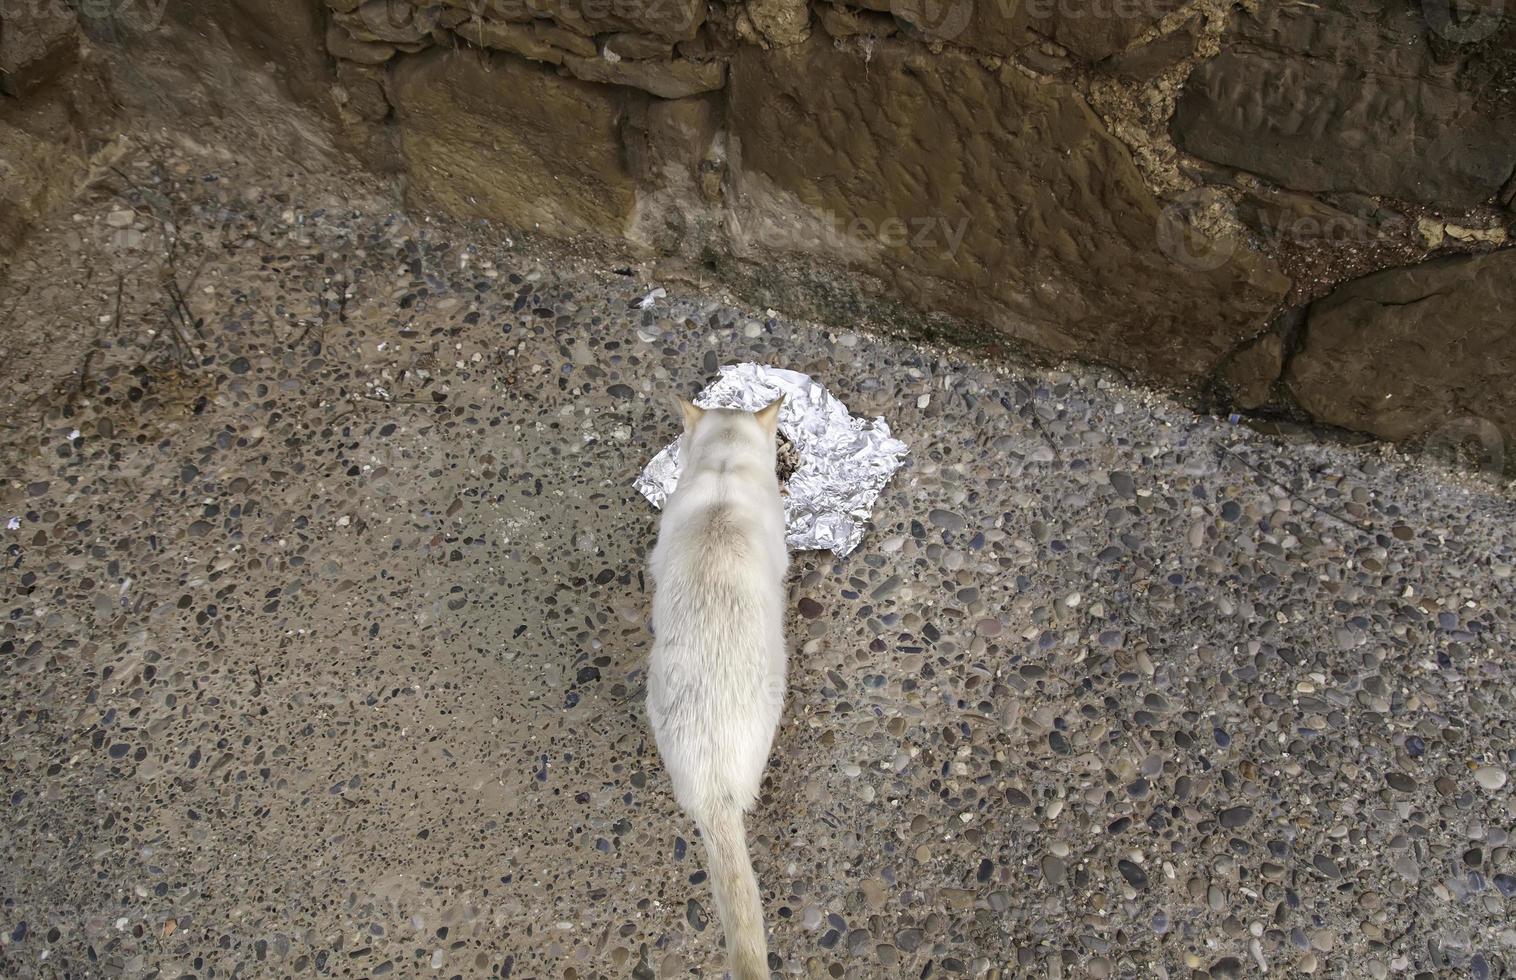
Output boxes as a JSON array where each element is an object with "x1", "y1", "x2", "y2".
[{"x1": 391, "y1": 50, "x2": 646, "y2": 237}]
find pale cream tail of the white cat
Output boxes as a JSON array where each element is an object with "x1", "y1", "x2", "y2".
[{"x1": 696, "y1": 801, "x2": 769, "y2": 980}]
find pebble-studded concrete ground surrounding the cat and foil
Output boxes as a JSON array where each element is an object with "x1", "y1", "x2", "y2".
[{"x1": 0, "y1": 129, "x2": 1516, "y2": 980}]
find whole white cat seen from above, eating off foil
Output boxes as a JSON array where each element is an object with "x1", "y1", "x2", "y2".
[{"x1": 647, "y1": 397, "x2": 790, "y2": 980}]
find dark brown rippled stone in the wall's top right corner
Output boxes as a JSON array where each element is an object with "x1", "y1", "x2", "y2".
[{"x1": 1173, "y1": 0, "x2": 1516, "y2": 208}]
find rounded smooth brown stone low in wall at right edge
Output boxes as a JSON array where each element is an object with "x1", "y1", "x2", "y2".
[{"x1": 1286, "y1": 249, "x2": 1516, "y2": 446}]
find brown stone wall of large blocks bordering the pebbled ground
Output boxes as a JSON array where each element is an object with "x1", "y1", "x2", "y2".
[{"x1": 0, "y1": 0, "x2": 1516, "y2": 466}]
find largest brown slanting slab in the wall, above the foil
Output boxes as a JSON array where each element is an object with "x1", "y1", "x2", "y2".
[{"x1": 729, "y1": 38, "x2": 1287, "y2": 381}]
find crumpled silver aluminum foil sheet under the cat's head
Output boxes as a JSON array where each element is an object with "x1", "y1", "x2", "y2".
[{"x1": 635, "y1": 364, "x2": 908, "y2": 555}]
